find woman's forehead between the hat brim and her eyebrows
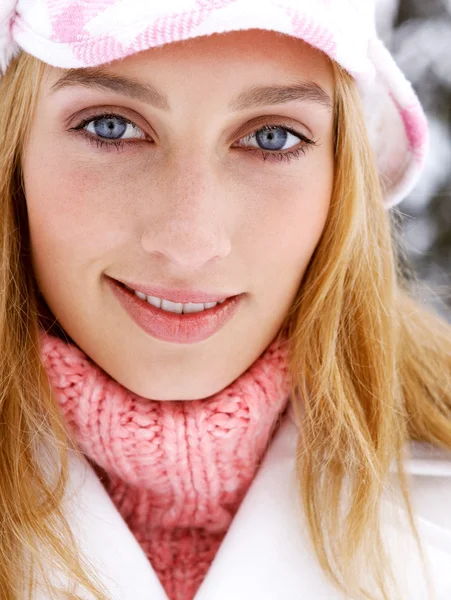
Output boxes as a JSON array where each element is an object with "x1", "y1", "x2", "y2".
[{"x1": 45, "y1": 30, "x2": 334, "y2": 101}]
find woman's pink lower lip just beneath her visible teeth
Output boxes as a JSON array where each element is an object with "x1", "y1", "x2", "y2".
[{"x1": 106, "y1": 277, "x2": 243, "y2": 344}]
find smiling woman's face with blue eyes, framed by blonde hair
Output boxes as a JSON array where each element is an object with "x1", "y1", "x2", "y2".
[{"x1": 23, "y1": 30, "x2": 334, "y2": 400}]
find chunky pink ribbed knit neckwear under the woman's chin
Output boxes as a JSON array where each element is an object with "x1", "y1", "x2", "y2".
[{"x1": 40, "y1": 332, "x2": 290, "y2": 600}]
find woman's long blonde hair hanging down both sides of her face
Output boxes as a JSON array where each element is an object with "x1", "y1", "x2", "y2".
[{"x1": 0, "y1": 53, "x2": 451, "y2": 600}]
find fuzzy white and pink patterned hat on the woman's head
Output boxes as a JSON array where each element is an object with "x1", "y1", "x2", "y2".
[{"x1": 0, "y1": 0, "x2": 428, "y2": 208}]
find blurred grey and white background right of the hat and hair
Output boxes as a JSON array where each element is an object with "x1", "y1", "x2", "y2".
[{"x1": 376, "y1": 0, "x2": 451, "y2": 322}]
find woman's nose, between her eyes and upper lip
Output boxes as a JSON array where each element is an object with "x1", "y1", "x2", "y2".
[{"x1": 141, "y1": 158, "x2": 231, "y2": 270}]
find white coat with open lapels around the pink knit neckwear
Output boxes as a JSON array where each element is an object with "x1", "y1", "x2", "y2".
[{"x1": 36, "y1": 409, "x2": 451, "y2": 600}]
